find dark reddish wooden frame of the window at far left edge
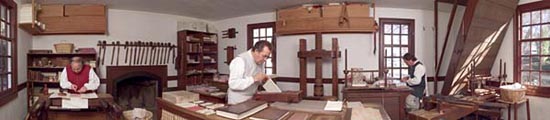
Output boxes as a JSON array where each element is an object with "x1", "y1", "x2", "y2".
[{"x1": 0, "y1": 0, "x2": 18, "y2": 107}]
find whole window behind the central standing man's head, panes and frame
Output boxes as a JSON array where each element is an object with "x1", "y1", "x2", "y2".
[{"x1": 247, "y1": 22, "x2": 277, "y2": 74}]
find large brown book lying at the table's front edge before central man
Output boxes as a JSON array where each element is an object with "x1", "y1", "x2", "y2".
[{"x1": 216, "y1": 100, "x2": 267, "y2": 120}]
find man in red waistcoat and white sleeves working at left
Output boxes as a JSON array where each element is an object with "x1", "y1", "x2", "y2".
[{"x1": 59, "y1": 57, "x2": 99, "y2": 93}]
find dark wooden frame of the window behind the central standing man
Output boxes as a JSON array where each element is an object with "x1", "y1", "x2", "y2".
[{"x1": 246, "y1": 22, "x2": 277, "y2": 74}]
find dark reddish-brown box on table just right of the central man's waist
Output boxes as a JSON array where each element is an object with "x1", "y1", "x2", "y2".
[{"x1": 253, "y1": 91, "x2": 303, "y2": 103}]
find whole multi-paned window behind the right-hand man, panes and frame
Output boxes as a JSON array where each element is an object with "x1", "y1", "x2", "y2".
[{"x1": 379, "y1": 18, "x2": 414, "y2": 79}]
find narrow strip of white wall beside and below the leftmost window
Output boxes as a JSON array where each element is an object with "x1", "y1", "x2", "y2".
[{"x1": 0, "y1": 0, "x2": 32, "y2": 120}]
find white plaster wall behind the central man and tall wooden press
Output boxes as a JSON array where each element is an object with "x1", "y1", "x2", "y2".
[{"x1": 214, "y1": 7, "x2": 464, "y2": 95}]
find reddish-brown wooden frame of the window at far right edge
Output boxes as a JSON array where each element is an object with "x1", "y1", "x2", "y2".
[{"x1": 513, "y1": 1, "x2": 550, "y2": 97}]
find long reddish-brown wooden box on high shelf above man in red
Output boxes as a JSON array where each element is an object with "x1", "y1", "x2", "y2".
[{"x1": 41, "y1": 16, "x2": 107, "y2": 34}]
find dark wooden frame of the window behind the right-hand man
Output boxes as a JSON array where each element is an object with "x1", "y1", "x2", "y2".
[{"x1": 378, "y1": 18, "x2": 415, "y2": 76}]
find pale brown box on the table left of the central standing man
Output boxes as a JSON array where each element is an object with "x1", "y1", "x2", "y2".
[{"x1": 162, "y1": 90, "x2": 199, "y2": 104}]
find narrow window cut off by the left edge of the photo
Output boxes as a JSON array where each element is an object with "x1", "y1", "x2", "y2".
[{"x1": 0, "y1": 0, "x2": 17, "y2": 106}]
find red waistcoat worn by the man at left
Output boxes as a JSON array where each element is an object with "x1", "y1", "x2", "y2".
[{"x1": 66, "y1": 65, "x2": 91, "y2": 90}]
